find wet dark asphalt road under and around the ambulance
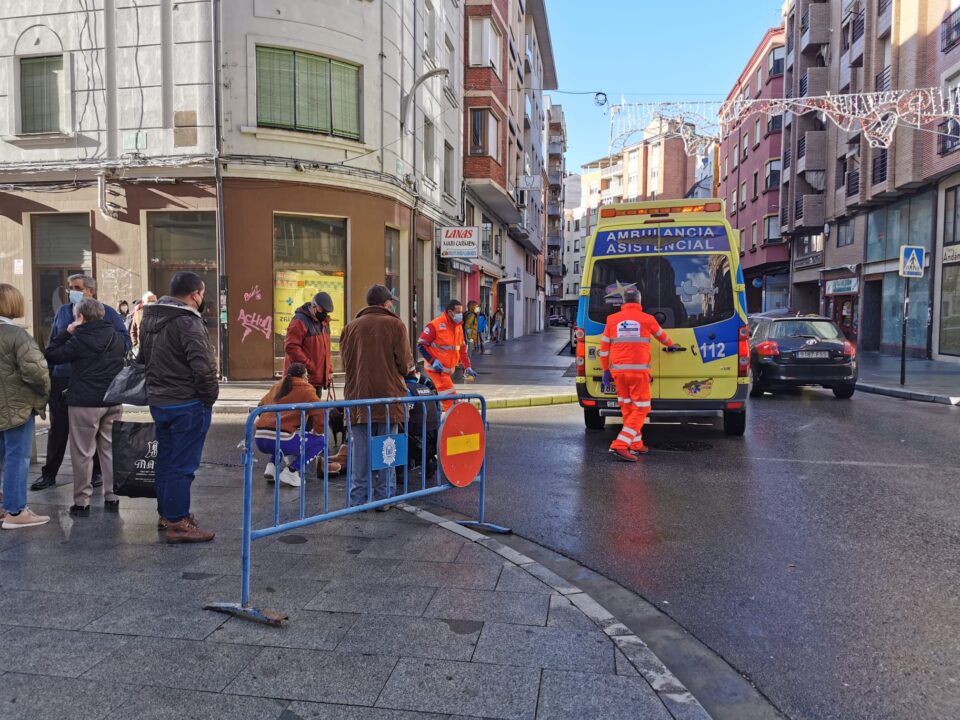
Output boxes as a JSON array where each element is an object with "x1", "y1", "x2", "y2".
[{"x1": 191, "y1": 390, "x2": 960, "y2": 720}]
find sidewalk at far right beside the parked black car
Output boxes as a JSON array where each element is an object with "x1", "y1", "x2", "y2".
[{"x1": 857, "y1": 352, "x2": 960, "y2": 405}]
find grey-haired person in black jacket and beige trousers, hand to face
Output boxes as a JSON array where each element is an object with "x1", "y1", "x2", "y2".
[{"x1": 46, "y1": 298, "x2": 127, "y2": 517}]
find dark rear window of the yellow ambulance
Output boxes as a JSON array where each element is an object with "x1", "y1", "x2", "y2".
[{"x1": 589, "y1": 253, "x2": 734, "y2": 328}]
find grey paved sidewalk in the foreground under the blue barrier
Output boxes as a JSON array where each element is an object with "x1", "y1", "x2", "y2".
[{"x1": 0, "y1": 458, "x2": 709, "y2": 720}]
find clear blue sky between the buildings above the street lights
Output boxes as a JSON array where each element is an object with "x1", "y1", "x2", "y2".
[{"x1": 546, "y1": 0, "x2": 782, "y2": 172}]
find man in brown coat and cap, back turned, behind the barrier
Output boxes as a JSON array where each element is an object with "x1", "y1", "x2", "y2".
[{"x1": 340, "y1": 285, "x2": 415, "y2": 511}]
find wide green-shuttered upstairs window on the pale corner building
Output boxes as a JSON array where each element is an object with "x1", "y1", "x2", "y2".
[{"x1": 257, "y1": 47, "x2": 361, "y2": 140}]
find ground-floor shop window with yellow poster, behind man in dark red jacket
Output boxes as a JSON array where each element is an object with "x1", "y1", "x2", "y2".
[{"x1": 273, "y1": 215, "x2": 349, "y2": 372}]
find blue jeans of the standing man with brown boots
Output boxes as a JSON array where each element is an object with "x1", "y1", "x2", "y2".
[{"x1": 150, "y1": 400, "x2": 212, "y2": 522}]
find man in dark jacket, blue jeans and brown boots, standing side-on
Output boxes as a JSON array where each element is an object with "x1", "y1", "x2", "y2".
[{"x1": 140, "y1": 272, "x2": 220, "y2": 543}]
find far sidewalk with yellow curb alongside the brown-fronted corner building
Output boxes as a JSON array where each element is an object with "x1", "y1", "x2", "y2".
[{"x1": 205, "y1": 328, "x2": 577, "y2": 414}]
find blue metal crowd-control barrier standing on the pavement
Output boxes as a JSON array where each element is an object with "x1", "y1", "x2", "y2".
[{"x1": 206, "y1": 394, "x2": 510, "y2": 626}]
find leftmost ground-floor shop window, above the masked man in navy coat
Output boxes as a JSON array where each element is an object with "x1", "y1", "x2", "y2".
[{"x1": 31, "y1": 213, "x2": 93, "y2": 346}]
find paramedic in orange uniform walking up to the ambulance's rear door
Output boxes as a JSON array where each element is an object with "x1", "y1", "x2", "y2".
[{"x1": 600, "y1": 285, "x2": 683, "y2": 462}]
